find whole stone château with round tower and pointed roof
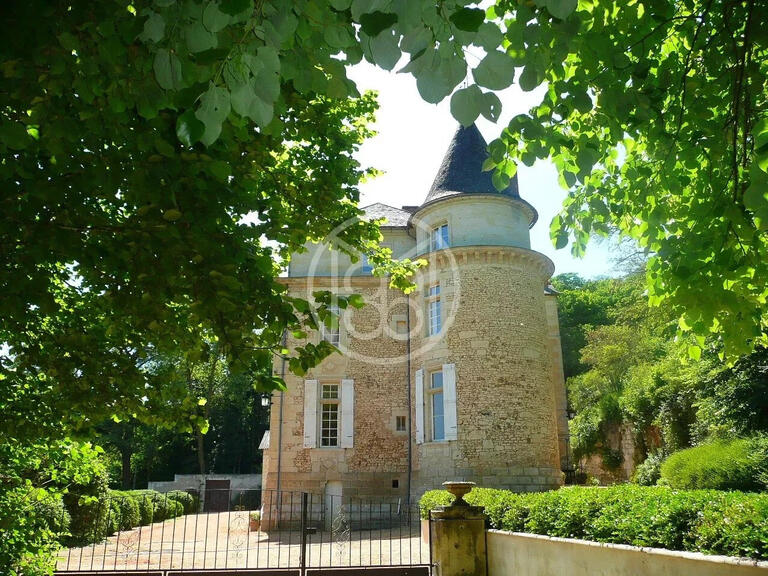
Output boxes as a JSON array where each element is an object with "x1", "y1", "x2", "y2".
[{"x1": 262, "y1": 126, "x2": 568, "y2": 501}]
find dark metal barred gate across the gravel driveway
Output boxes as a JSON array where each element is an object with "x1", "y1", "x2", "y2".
[{"x1": 56, "y1": 488, "x2": 430, "y2": 576}]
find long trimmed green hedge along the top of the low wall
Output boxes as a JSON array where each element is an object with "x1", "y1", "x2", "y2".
[{"x1": 419, "y1": 484, "x2": 768, "y2": 559}]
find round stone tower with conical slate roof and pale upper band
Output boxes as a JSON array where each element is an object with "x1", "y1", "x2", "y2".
[{"x1": 411, "y1": 125, "x2": 567, "y2": 493}]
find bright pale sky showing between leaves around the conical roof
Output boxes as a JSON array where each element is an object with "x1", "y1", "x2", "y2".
[{"x1": 348, "y1": 62, "x2": 618, "y2": 278}]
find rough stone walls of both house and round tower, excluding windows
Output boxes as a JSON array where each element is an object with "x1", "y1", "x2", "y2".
[{"x1": 264, "y1": 247, "x2": 567, "y2": 500}]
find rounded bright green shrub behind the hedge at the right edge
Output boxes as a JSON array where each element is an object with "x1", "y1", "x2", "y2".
[{"x1": 661, "y1": 436, "x2": 768, "y2": 490}]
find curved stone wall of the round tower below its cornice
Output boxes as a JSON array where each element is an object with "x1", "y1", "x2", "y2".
[{"x1": 412, "y1": 247, "x2": 562, "y2": 494}]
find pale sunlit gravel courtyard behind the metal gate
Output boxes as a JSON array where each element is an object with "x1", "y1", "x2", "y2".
[{"x1": 56, "y1": 512, "x2": 429, "y2": 572}]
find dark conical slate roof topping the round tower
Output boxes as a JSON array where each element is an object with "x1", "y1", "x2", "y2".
[{"x1": 424, "y1": 124, "x2": 519, "y2": 204}]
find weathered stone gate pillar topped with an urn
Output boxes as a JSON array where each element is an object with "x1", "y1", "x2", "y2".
[{"x1": 429, "y1": 482, "x2": 488, "y2": 576}]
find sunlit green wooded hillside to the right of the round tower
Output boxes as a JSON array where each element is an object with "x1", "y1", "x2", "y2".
[{"x1": 553, "y1": 266, "x2": 768, "y2": 489}]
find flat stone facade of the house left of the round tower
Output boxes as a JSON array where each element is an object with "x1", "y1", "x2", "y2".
[{"x1": 264, "y1": 277, "x2": 408, "y2": 500}]
